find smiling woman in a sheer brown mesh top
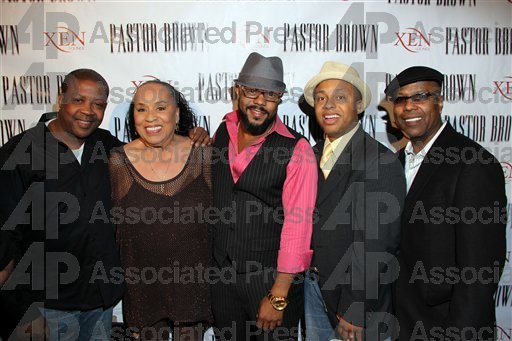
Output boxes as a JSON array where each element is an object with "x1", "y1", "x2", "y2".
[{"x1": 110, "y1": 80, "x2": 212, "y2": 340}]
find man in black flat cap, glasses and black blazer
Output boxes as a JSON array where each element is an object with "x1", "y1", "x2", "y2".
[{"x1": 385, "y1": 66, "x2": 507, "y2": 340}]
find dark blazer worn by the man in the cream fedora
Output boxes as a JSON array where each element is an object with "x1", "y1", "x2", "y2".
[{"x1": 312, "y1": 127, "x2": 405, "y2": 340}]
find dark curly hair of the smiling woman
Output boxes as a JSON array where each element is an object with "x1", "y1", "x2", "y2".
[{"x1": 127, "y1": 79, "x2": 197, "y2": 141}]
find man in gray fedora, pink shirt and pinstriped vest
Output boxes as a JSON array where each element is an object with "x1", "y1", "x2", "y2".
[{"x1": 212, "y1": 53, "x2": 317, "y2": 341}]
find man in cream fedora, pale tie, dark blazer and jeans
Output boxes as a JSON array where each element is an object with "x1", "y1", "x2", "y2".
[{"x1": 304, "y1": 62, "x2": 405, "y2": 341}]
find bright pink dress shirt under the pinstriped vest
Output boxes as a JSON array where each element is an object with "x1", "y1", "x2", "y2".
[{"x1": 224, "y1": 111, "x2": 318, "y2": 273}]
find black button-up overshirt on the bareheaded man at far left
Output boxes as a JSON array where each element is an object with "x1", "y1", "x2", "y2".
[{"x1": 0, "y1": 113, "x2": 124, "y2": 334}]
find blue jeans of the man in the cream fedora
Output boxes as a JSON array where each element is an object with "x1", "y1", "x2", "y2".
[{"x1": 304, "y1": 270, "x2": 335, "y2": 341}]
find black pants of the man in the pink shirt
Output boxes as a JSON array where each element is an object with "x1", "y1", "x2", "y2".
[{"x1": 211, "y1": 263, "x2": 304, "y2": 341}]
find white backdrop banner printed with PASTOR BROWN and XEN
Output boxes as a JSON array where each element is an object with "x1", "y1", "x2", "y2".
[{"x1": 0, "y1": 0, "x2": 512, "y2": 340}]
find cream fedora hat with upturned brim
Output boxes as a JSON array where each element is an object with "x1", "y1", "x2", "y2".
[{"x1": 304, "y1": 61, "x2": 372, "y2": 112}]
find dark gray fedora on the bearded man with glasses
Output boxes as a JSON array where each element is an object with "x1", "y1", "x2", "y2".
[{"x1": 235, "y1": 52, "x2": 286, "y2": 92}]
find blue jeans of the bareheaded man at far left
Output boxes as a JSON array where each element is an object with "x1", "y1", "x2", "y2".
[{"x1": 41, "y1": 308, "x2": 113, "y2": 341}]
